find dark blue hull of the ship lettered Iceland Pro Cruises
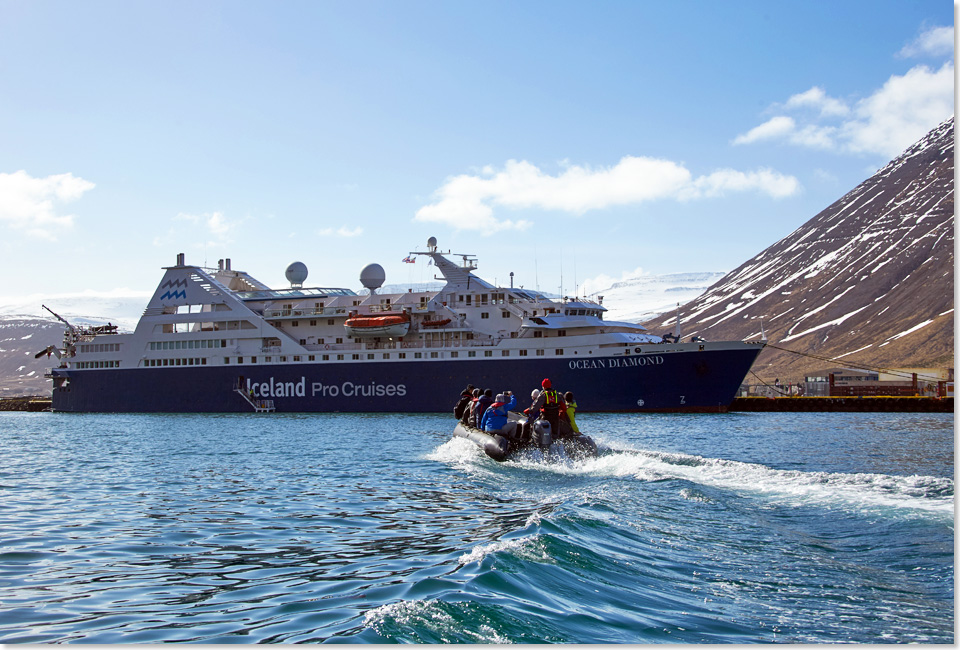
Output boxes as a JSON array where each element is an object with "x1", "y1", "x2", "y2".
[{"x1": 51, "y1": 344, "x2": 763, "y2": 413}]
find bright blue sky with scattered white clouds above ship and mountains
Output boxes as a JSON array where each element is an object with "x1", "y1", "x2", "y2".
[{"x1": 0, "y1": 0, "x2": 955, "y2": 306}]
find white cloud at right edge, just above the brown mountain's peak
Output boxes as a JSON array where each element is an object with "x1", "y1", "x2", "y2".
[{"x1": 733, "y1": 62, "x2": 954, "y2": 158}]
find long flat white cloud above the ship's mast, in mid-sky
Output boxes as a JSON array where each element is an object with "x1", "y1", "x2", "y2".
[{"x1": 414, "y1": 156, "x2": 799, "y2": 234}]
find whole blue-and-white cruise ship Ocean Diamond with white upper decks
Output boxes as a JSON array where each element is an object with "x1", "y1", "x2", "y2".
[{"x1": 48, "y1": 237, "x2": 763, "y2": 413}]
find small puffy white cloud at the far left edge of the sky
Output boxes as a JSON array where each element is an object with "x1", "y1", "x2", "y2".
[{"x1": 0, "y1": 170, "x2": 95, "y2": 240}]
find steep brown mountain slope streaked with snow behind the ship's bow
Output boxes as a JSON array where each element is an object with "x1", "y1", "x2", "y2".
[{"x1": 646, "y1": 117, "x2": 954, "y2": 379}]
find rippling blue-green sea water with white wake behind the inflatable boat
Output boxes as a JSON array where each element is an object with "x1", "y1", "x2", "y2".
[{"x1": 0, "y1": 411, "x2": 954, "y2": 643}]
